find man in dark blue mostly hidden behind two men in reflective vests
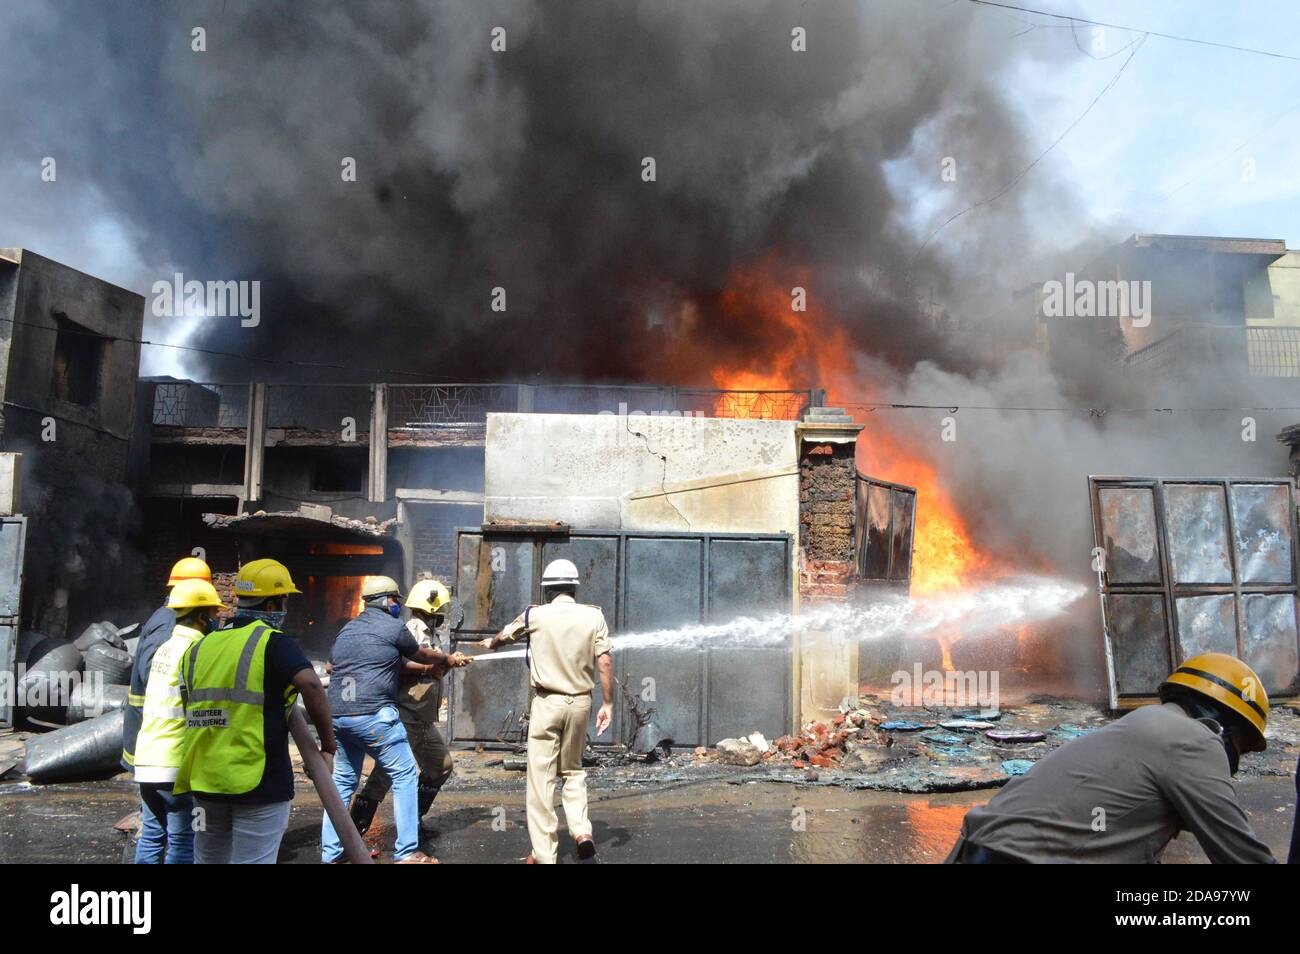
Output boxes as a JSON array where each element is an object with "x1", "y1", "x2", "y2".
[{"x1": 121, "y1": 556, "x2": 212, "y2": 864}]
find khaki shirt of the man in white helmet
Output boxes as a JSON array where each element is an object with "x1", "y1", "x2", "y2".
[{"x1": 497, "y1": 594, "x2": 614, "y2": 695}]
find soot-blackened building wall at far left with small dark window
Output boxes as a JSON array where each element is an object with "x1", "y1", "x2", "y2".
[{"x1": 0, "y1": 250, "x2": 144, "y2": 634}]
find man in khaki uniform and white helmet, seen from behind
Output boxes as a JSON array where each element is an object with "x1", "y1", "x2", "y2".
[{"x1": 481, "y1": 560, "x2": 614, "y2": 864}]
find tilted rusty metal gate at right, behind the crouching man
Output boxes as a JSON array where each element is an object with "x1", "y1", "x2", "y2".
[{"x1": 1088, "y1": 477, "x2": 1300, "y2": 707}]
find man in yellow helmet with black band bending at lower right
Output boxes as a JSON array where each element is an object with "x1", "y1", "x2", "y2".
[{"x1": 948, "y1": 652, "x2": 1274, "y2": 864}]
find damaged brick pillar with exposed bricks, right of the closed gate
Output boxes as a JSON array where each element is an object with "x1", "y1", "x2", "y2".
[{"x1": 796, "y1": 407, "x2": 862, "y2": 723}]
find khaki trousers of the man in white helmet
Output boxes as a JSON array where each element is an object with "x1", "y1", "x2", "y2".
[{"x1": 528, "y1": 693, "x2": 592, "y2": 864}]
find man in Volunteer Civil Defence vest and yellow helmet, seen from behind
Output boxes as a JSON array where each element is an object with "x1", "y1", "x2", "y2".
[{"x1": 174, "y1": 560, "x2": 334, "y2": 864}]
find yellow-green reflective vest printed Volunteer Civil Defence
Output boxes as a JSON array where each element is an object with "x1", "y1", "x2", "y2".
[{"x1": 173, "y1": 621, "x2": 298, "y2": 795}]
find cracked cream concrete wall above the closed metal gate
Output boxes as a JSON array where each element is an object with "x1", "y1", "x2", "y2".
[{"x1": 484, "y1": 413, "x2": 800, "y2": 538}]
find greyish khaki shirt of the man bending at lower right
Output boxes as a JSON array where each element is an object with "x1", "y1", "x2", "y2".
[{"x1": 948, "y1": 702, "x2": 1274, "y2": 864}]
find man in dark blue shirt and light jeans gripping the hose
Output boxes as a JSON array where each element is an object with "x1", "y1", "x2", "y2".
[{"x1": 321, "y1": 576, "x2": 465, "y2": 864}]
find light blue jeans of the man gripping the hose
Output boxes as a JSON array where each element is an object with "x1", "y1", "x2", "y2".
[{"x1": 321, "y1": 706, "x2": 420, "y2": 864}]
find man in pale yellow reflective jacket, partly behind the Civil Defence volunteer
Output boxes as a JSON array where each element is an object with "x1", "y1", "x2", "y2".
[{"x1": 133, "y1": 578, "x2": 225, "y2": 864}]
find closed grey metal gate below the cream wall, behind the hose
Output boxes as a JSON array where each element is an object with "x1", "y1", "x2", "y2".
[{"x1": 449, "y1": 528, "x2": 793, "y2": 746}]
